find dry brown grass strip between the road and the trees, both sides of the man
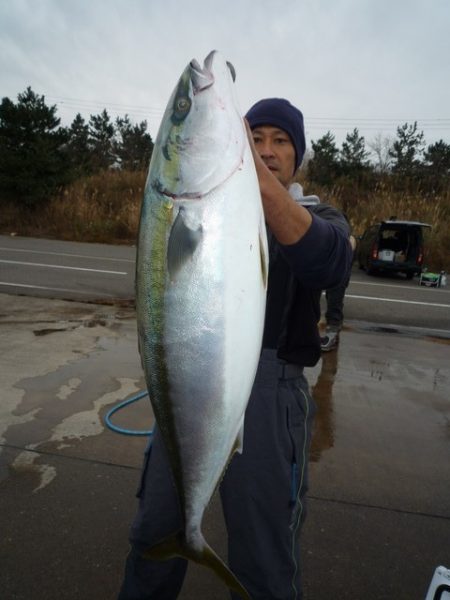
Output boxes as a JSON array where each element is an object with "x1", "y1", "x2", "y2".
[{"x1": 0, "y1": 171, "x2": 450, "y2": 271}]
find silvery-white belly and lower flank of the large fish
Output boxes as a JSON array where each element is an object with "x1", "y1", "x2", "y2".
[{"x1": 164, "y1": 152, "x2": 265, "y2": 522}]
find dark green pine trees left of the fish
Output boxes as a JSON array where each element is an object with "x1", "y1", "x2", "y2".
[{"x1": 0, "y1": 87, "x2": 153, "y2": 208}]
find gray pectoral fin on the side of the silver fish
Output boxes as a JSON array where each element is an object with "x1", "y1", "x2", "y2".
[{"x1": 167, "y1": 207, "x2": 203, "y2": 278}]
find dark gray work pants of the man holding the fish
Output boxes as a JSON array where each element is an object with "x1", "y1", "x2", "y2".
[{"x1": 119, "y1": 351, "x2": 315, "y2": 600}]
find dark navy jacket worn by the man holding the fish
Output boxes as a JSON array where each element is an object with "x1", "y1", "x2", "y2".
[{"x1": 263, "y1": 204, "x2": 352, "y2": 367}]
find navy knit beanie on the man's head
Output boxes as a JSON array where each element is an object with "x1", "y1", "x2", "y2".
[{"x1": 245, "y1": 98, "x2": 306, "y2": 170}]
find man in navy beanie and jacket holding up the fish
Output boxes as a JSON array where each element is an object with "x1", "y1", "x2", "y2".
[{"x1": 119, "y1": 98, "x2": 351, "y2": 600}]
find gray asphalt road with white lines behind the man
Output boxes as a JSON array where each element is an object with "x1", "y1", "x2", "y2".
[{"x1": 0, "y1": 236, "x2": 450, "y2": 334}]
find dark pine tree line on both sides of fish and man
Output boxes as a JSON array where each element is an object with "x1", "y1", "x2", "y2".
[{"x1": 0, "y1": 87, "x2": 450, "y2": 207}]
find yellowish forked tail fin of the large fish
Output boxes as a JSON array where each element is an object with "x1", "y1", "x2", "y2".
[{"x1": 142, "y1": 532, "x2": 251, "y2": 600}]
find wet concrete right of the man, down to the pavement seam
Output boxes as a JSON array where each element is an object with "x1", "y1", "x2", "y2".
[{"x1": 310, "y1": 325, "x2": 450, "y2": 518}]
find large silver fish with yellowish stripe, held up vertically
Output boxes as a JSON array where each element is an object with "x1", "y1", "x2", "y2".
[{"x1": 136, "y1": 51, "x2": 267, "y2": 598}]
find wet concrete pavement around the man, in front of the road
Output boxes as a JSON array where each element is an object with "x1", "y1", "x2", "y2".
[{"x1": 0, "y1": 294, "x2": 450, "y2": 600}]
